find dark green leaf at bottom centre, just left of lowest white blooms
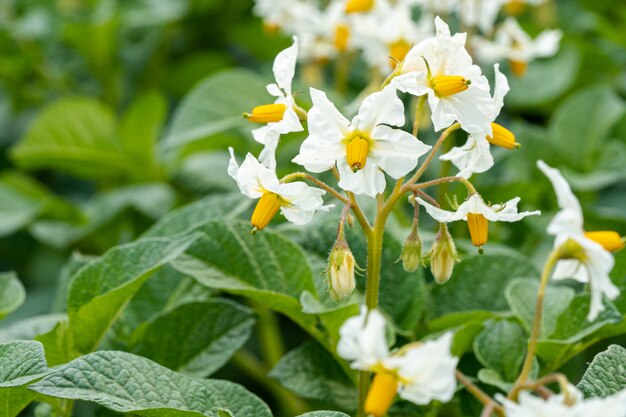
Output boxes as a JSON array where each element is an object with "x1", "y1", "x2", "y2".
[{"x1": 269, "y1": 342, "x2": 357, "y2": 410}]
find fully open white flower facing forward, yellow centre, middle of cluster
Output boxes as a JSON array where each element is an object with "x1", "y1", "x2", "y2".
[{"x1": 293, "y1": 87, "x2": 430, "y2": 197}]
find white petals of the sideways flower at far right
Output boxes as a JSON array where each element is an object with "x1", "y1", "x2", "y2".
[{"x1": 537, "y1": 161, "x2": 619, "y2": 321}]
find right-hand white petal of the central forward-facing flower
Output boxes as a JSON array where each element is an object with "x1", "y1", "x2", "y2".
[{"x1": 368, "y1": 125, "x2": 431, "y2": 179}]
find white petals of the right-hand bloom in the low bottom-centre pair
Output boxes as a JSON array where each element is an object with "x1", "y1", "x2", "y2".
[{"x1": 383, "y1": 332, "x2": 459, "y2": 405}]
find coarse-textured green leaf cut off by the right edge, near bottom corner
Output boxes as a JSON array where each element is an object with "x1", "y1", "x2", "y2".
[{"x1": 578, "y1": 345, "x2": 626, "y2": 398}]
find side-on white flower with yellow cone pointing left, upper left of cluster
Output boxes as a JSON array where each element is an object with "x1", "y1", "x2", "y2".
[{"x1": 248, "y1": 36, "x2": 303, "y2": 169}]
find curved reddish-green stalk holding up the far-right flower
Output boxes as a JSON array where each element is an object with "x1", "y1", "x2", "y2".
[{"x1": 508, "y1": 249, "x2": 561, "y2": 400}]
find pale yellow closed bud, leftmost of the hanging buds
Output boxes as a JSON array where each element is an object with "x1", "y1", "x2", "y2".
[{"x1": 328, "y1": 238, "x2": 356, "y2": 301}]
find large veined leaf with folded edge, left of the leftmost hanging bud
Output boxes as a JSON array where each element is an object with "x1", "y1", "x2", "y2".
[{"x1": 172, "y1": 220, "x2": 316, "y2": 338}]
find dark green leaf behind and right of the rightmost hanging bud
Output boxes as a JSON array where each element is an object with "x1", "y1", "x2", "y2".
[{"x1": 429, "y1": 254, "x2": 538, "y2": 317}]
